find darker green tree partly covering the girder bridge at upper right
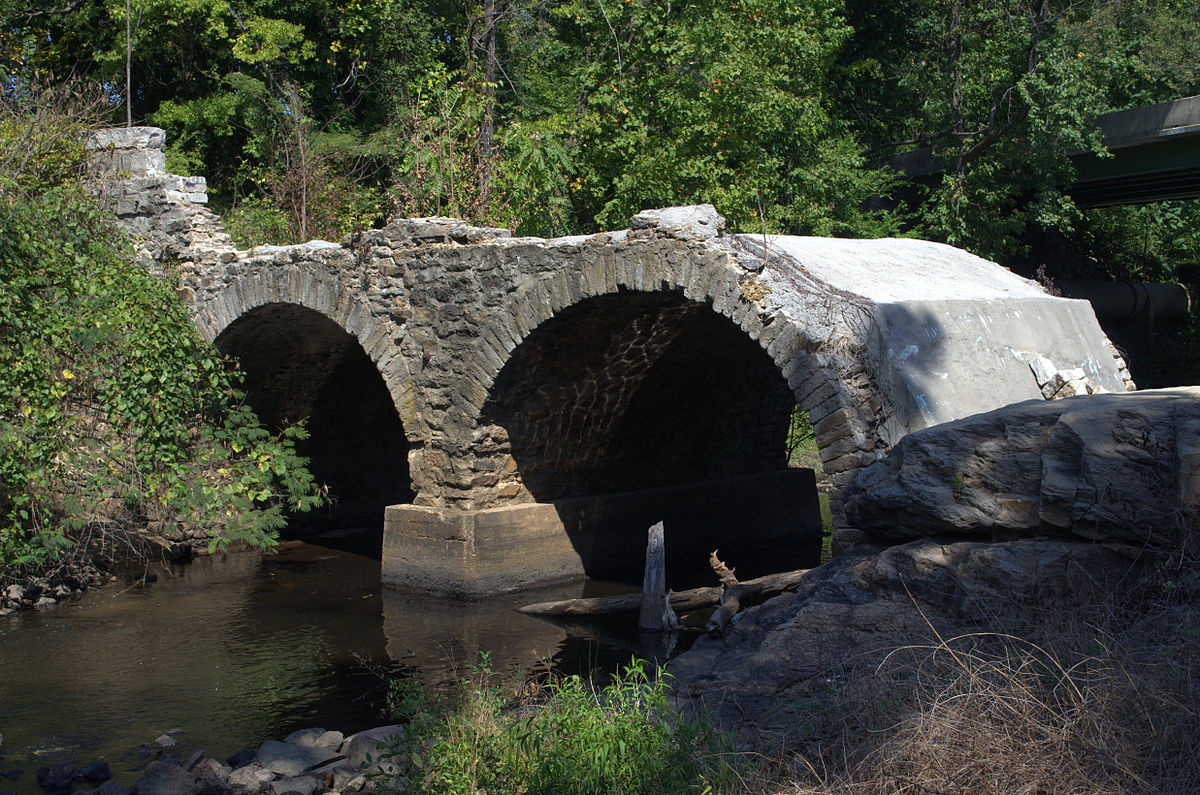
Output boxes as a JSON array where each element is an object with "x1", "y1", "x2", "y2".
[{"x1": 839, "y1": 0, "x2": 1200, "y2": 262}]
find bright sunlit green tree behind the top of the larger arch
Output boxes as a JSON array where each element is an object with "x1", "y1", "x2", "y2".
[{"x1": 514, "y1": 0, "x2": 887, "y2": 234}]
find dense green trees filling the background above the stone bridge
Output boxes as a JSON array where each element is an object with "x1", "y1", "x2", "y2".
[{"x1": 0, "y1": 0, "x2": 1200, "y2": 261}]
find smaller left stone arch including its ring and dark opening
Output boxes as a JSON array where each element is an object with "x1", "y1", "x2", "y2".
[{"x1": 197, "y1": 267, "x2": 414, "y2": 533}]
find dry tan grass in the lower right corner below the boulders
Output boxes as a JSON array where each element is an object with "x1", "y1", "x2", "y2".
[{"x1": 758, "y1": 559, "x2": 1200, "y2": 795}]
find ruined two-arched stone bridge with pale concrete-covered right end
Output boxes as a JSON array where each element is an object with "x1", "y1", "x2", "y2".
[{"x1": 92, "y1": 127, "x2": 1132, "y2": 594}]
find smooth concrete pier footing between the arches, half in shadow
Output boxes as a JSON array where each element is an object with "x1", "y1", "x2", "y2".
[{"x1": 383, "y1": 470, "x2": 821, "y2": 597}]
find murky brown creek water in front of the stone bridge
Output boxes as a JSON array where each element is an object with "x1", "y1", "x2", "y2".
[{"x1": 0, "y1": 542, "x2": 667, "y2": 793}]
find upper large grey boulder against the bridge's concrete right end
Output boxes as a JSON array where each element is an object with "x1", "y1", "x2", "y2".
[{"x1": 844, "y1": 387, "x2": 1200, "y2": 548}]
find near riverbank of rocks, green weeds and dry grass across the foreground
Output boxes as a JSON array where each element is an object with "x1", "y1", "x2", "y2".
[{"x1": 0, "y1": 539, "x2": 1200, "y2": 795}]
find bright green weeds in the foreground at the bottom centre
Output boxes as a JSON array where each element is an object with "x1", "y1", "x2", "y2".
[{"x1": 376, "y1": 660, "x2": 736, "y2": 795}]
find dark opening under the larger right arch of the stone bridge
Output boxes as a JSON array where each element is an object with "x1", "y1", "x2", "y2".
[{"x1": 484, "y1": 292, "x2": 821, "y2": 587}]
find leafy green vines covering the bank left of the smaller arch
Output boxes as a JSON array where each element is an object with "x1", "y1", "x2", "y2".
[{"x1": 0, "y1": 107, "x2": 322, "y2": 578}]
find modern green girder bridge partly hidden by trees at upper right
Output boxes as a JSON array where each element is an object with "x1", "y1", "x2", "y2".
[{"x1": 893, "y1": 96, "x2": 1200, "y2": 207}]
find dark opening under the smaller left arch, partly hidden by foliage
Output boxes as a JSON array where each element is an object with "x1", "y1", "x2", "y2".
[{"x1": 216, "y1": 304, "x2": 413, "y2": 536}]
